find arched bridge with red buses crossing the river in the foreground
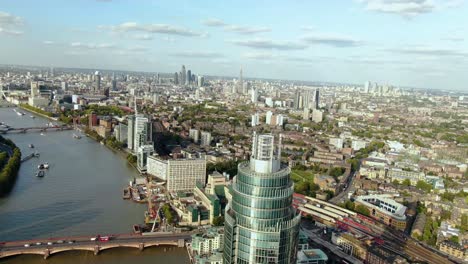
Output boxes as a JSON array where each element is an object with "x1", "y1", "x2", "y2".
[{"x1": 0, "y1": 232, "x2": 191, "y2": 259}]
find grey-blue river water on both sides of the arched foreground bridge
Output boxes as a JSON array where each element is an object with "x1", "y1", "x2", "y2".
[{"x1": 0, "y1": 108, "x2": 189, "y2": 264}]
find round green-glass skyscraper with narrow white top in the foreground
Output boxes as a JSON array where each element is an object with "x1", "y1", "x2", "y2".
[{"x1": 223, "y1": 134, "x2": 300, "y2": 264}]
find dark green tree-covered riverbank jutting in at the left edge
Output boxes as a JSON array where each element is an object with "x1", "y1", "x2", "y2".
[{"x1": 0, "y1": 136, "x2": 21, "y2": 197}]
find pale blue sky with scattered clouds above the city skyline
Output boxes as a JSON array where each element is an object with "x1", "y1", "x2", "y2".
[{"x1": 0, "y1": 0, "x2": 468, "y2": 91}]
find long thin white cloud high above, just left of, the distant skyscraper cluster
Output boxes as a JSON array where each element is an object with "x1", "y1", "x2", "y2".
[{"x1": 98, "y1": 22, "x2": 202, "y2": 37}]
